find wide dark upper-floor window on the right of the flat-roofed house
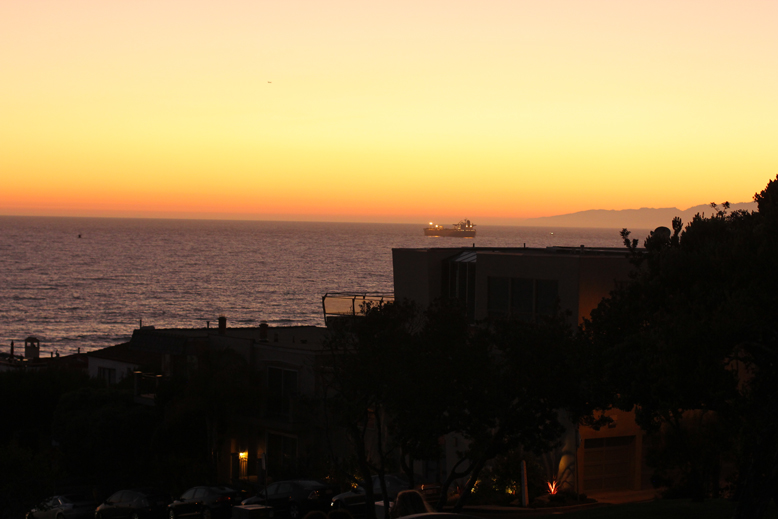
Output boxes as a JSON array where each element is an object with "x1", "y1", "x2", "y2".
[{"x1": 487, "y1": 276, "x2": 559, "y2": 321}]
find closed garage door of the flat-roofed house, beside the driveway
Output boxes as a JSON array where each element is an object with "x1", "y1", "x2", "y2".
[{"x1": 583, "y1": 436, "x2": 635, "y2": 492}]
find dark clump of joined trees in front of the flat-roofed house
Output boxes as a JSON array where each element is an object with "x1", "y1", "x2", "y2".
[{"x1": 324, "y1": 301, "x2": 608, "y2": 514}]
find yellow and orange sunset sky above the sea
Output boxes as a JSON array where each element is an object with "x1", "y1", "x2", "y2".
[{"x1": 0, "y1": 0, "x2": 778, "y2": 223}]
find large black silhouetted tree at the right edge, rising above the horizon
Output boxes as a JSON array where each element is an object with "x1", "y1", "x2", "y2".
[{"x1": 585, "y1": 179, "x2": 778, "y2": 518}]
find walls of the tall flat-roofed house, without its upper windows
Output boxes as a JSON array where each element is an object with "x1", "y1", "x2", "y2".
[{"x1": 393, "y1": 249, "x2": 643, "y2": 500}]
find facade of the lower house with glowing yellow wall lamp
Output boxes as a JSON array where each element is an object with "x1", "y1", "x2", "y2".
[{"x1": 130, "y1": 320, "x2": 326, "y2": 484}]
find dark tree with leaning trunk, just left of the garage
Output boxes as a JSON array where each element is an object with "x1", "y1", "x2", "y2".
[{"x1": 439, "y1": 313, "x2": 611, "y2": 512}]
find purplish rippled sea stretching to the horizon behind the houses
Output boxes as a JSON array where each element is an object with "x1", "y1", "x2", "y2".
[{"x1": 0, "y1": 216, "x2": 646, "y2": 355}]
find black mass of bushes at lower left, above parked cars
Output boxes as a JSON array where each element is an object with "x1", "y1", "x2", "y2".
[{"x1": 0, "y1": 352, "x2": 261, "y2": 518}]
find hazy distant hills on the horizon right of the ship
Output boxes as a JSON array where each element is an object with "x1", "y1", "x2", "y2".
[{"x1": 522, "y1": 202, "x2": 756, "y2": 229}]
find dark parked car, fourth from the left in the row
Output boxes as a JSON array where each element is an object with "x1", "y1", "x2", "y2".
[{"x1": 241, "y1": 479, "x2": 335, "y2": 519}]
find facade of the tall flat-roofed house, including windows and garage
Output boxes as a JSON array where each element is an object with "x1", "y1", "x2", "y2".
[{"x1": 392, "y1": 247, "x2": 650, "y2": 493}]
